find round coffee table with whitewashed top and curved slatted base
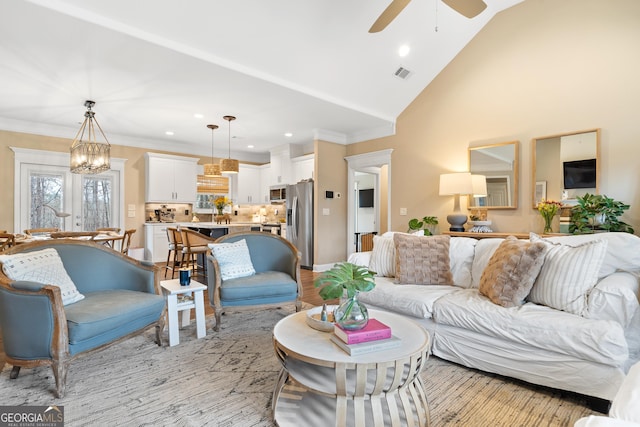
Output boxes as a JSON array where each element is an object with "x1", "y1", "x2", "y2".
[{"x1": 272, "y1": 310, "x2": 430, "y2": 427}]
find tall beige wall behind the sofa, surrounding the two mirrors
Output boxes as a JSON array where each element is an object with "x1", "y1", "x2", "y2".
[{"x1": 347, "y1": 0, "x2": 640, "y2": 237}]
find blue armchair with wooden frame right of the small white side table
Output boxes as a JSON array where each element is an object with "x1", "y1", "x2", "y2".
[{"x1": 207, "y1": 231, "x2": 302, "y2": 331}]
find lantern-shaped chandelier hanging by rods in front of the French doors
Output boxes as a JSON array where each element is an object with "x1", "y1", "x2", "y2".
[{"x1": 69, "y1": 101, "x2": 111, "y2": 174}]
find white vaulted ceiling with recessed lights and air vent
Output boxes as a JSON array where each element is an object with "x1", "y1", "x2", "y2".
[{"x1": 0, "y1": 0, "x2": 523, "y2": 161}]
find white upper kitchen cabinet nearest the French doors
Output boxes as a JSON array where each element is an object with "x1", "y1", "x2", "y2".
[{"x1": 145, "y1": 153, "x2": 198, "y2": 203}]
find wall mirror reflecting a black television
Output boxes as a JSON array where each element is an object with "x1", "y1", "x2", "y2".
[{"x1": 531, "y1": 129, "x2": 600, "y2": 209}]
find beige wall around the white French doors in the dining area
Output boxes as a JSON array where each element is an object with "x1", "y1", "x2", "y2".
[{"x1": 0, "y1": 130, "x2": 209, "y2": 246}]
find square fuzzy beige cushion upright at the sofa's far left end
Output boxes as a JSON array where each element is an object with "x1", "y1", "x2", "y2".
[{"x1": 393, "y1": 233, "x2": 453, "y2": 285}]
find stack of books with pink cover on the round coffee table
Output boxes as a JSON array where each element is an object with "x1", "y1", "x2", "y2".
[{"x1": 331, "y1": 319, "x2": 402, "y2": 356}]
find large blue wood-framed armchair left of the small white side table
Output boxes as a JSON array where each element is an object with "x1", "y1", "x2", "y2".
[{"x1": 0, "y1": 239, "x2": 165, "y2": 397}]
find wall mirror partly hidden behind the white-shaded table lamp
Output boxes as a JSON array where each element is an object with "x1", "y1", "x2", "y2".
[{"x1": 468, "y1": 141, "x2": 519, "y2": 209}]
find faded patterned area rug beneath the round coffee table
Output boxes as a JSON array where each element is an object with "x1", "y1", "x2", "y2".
[{"x1": 0, "y1": 307, "x2": 593, "y2": 427}]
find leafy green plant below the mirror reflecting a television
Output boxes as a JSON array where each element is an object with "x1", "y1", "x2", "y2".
[{"x1": 569, "y1": 193, "x2": 634, "y2": 234}]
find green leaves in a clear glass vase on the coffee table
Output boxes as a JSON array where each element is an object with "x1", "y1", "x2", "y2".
[{"x1": 313, "y1": 262, "x2": 376, "y2": 330}]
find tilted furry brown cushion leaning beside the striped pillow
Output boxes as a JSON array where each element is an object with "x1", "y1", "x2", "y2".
[{"x1": 480, "y1": 236, "x2": 546, "y2": 307}]
